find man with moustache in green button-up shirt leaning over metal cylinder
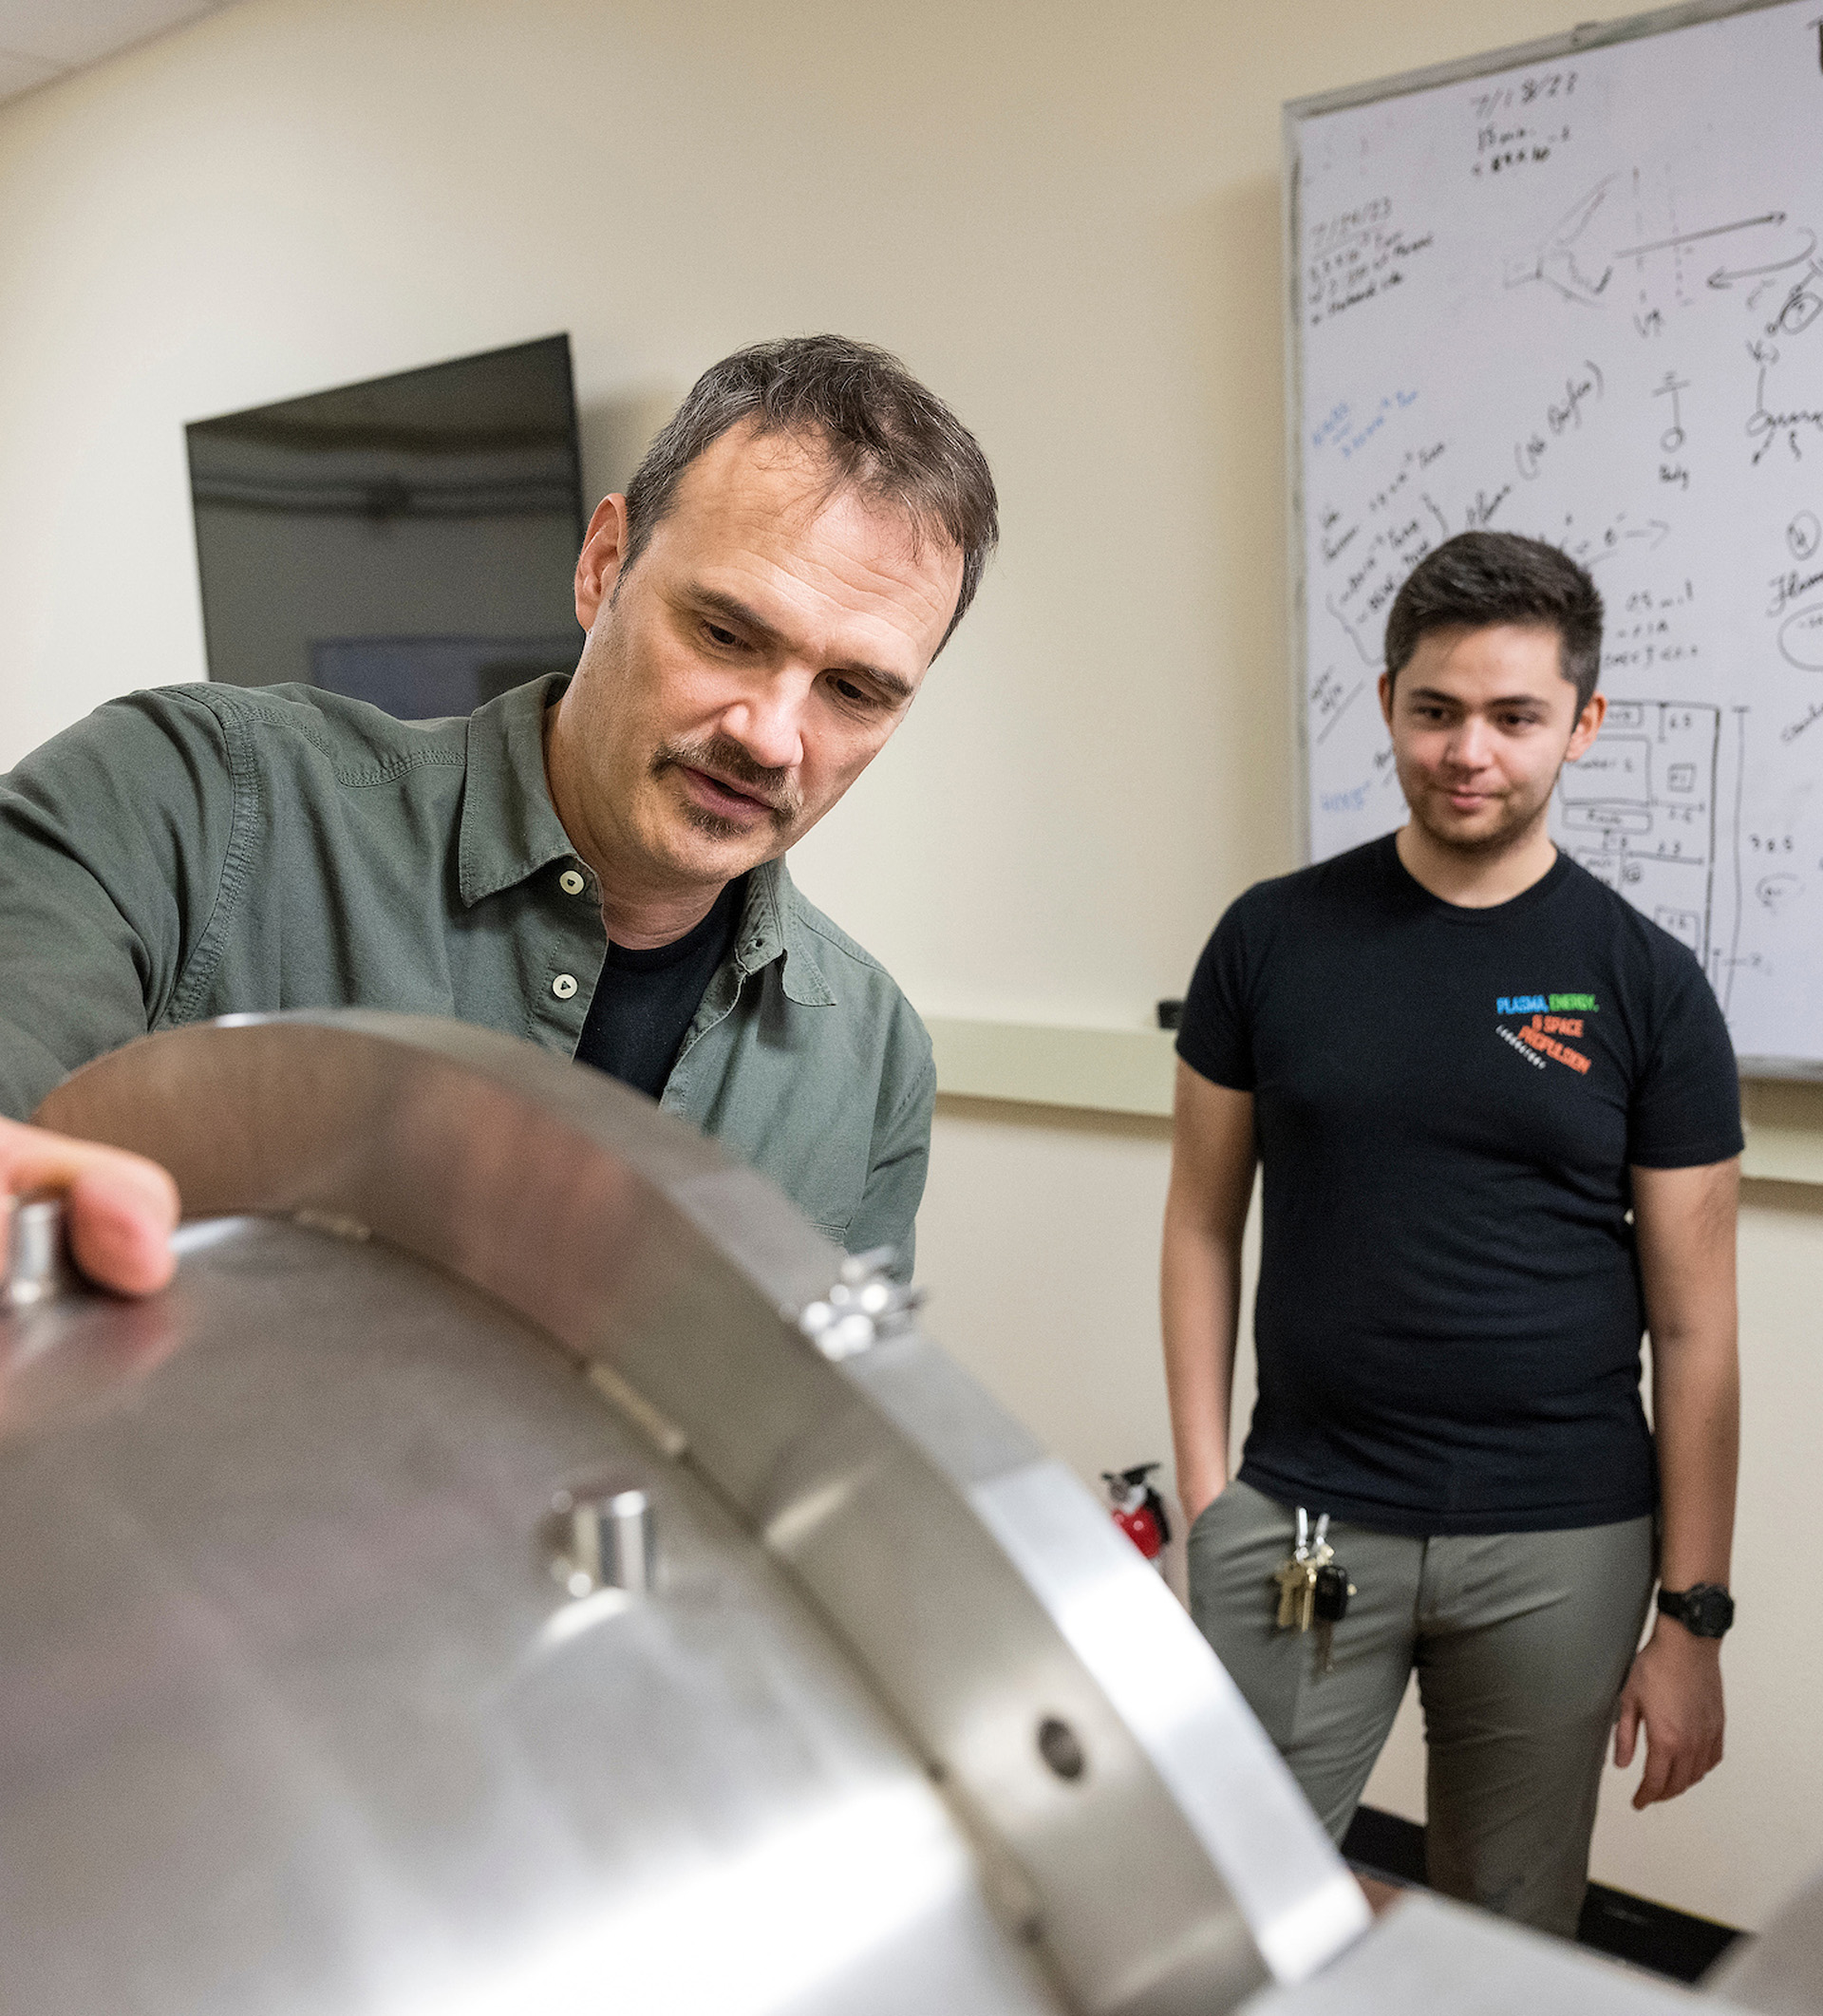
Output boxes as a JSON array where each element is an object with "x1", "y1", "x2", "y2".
[{"x1": 0, "y1": 337, "x2": 996, "y2": 1286}]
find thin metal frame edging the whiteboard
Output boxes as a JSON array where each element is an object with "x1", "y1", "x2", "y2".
[{"x1": 1279, "y1": 0, "x2": 1823, "y2": 1081}]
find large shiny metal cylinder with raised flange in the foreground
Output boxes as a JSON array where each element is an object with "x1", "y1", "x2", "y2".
[{"x1": 0, "y1": 1014, "x2": 1785, "y2": 2016}]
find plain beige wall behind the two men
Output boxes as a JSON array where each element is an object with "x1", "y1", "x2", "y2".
[{"x1": 0, "y1": 0, "x2": 1823, "y2": 1921}]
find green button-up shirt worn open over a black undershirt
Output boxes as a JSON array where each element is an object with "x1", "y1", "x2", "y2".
[{"x1": 0, "y1": 677, "x2": 935, "y2": 1274}]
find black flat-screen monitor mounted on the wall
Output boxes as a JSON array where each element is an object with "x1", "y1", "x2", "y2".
[{"x1": 185, "y1": 337, "x2": 585, "y2": 720}]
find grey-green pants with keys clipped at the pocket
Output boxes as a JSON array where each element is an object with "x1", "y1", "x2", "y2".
[{"x1": 1190, "y1": 1481, "x2": 1654, "y2": 1937}]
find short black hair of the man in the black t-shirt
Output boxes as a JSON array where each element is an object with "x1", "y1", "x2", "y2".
[{"x1": 1385, "y1": 532, "x2": 1601, "y2": 714}]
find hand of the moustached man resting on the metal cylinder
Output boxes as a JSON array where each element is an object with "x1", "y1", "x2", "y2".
[{"x1": 0, "y1": 1119, "x2": 178, "y2": 1294}]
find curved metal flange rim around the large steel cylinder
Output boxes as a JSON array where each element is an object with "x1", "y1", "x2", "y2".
[{"x1": 36, "y1": 1010, "x2": 1365, "y2": 2016}]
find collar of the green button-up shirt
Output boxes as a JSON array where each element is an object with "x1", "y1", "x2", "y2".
[{"x1": 458, "y1": 671, "x2": 835, "y2": 1008}]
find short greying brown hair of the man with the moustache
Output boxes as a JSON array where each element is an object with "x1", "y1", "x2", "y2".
[{"x1": 621, "y1": 337, "x2": 1000, "y2": 651}]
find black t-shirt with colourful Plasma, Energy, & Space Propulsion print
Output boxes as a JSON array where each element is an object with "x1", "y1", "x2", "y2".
[{"x1": 1177, "y1": 837, "x2": 1742, "y2": 1535}]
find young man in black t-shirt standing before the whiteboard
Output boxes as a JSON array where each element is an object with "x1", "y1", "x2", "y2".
[{"x1": 1163, "y1": 532, "x2": 1742, "y2": 1935}]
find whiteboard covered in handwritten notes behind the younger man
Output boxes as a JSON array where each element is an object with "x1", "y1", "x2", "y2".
[{"x1": 1287, "y1": 0, "x2": 1823, "y2": 1075}]
